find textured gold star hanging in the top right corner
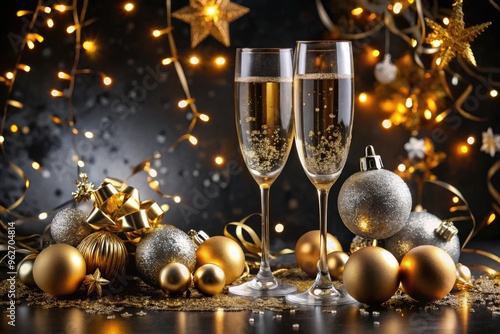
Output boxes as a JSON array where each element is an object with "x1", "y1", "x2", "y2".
[{"x1": 425, "y1": 0, "x2": 491, "y2": 70}]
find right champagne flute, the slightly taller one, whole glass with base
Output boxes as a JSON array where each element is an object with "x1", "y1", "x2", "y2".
[{"x1": 286, "y1": 41, "x2": 355, "y2": 306}]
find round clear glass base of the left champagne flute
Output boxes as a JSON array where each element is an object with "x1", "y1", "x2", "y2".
[{"x1": 229, "y1": 278, "x2": 297, "y2": 297}]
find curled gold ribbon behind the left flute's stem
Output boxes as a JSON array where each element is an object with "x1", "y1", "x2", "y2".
[{"x1": 224, "y1": 213, "x2": 294, "y2": 266}]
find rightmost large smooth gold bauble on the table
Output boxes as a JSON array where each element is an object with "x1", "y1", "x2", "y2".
[{"x1": 399, "y1": 245, "x2": 456, "y2": 302}]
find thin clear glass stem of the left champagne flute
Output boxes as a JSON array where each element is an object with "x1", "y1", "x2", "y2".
[{"x1": 257, "y1": 184, "x2": 274, "y2": 282}]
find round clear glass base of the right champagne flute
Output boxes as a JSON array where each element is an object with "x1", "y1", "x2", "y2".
[{"x1": 285, "y1": 286, "x2": 357, "y2": 306}]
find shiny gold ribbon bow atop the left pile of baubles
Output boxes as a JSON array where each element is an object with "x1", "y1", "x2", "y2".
[{"x1": 86, "y1": 178, "x2": 164, "y2": 245}]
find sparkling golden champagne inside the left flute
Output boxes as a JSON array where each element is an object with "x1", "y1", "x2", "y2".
[{"x1": 235, "y1": 77, "x2": 293, "y2": 186}]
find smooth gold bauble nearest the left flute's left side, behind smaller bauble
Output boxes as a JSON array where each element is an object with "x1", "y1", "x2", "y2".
[{"x1": 196, "y1": 236, "x2": 245, "y2": 284}]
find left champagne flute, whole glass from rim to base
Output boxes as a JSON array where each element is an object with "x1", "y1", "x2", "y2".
[{"x1": 229, "y1": 48, "x2": 297, "y2": 297}]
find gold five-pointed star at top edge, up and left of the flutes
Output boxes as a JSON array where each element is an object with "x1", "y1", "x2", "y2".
[{"x1": 172, "y1": 0, "x2": 250, "y2": 48}]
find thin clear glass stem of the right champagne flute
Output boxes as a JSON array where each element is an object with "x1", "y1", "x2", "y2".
[{"x1": 316, "y1": 188, "x2": 333, "y2": 289}]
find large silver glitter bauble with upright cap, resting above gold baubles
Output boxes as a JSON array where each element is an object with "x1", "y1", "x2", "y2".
[{"x1": 338, "y1": 145, "x2": 412, "y2": 240}]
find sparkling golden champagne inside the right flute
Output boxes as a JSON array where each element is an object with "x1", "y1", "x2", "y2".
[{"x1": 293, "y1": 73, "x2": 354, "y2": 186}]
